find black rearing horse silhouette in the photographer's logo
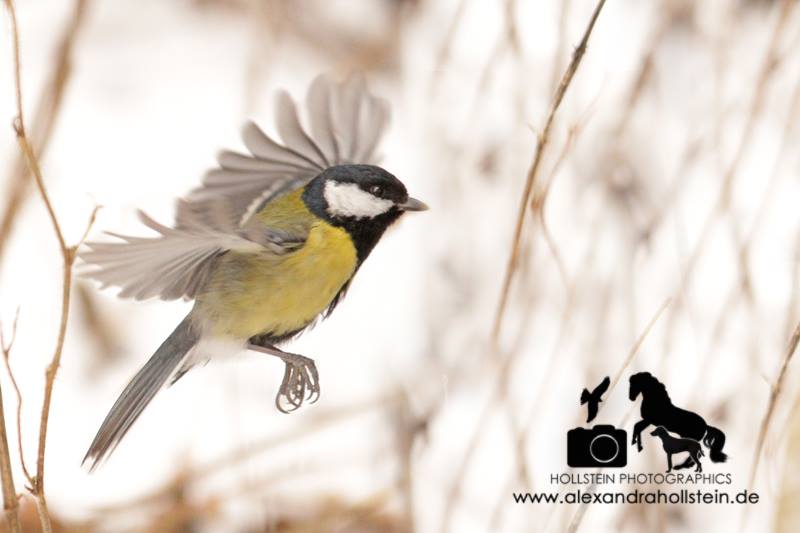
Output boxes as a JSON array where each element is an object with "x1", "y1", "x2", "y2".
[{"x1": 628, "y1": 372, "x2": 728, "y2": 468}]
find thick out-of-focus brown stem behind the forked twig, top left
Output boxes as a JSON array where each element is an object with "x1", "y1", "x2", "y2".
[{"x1": 0, "y1": 0, "x2": 87, "y2": 259}]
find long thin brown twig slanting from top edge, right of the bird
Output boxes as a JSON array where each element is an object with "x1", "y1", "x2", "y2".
[{"x1": 492, "y1": 0, "x2": 606, "y2": 348}]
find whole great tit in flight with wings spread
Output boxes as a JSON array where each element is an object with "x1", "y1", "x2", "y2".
[{"x1": 79, "y1": 74, "x2": 427, "y2": 471}]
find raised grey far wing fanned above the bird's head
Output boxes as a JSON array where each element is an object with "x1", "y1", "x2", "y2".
[{"x1": 177, "y1": 72, "x2": 389, "y2": 225}]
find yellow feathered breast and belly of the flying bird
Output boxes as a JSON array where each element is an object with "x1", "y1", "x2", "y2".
[{"x1": 195, "y1": 208, "x2": 357, "y2": 339}]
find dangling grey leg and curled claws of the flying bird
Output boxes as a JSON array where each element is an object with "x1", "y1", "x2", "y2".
[{"x1": 247, "y1": 343, "x2": 319, "y2": 413}]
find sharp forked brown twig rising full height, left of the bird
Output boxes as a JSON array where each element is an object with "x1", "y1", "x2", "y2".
[{"x1": 5, "y1": 0, "x2": 97, "y2": 533}]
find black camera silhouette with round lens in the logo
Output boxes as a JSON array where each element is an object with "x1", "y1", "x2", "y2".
[{"x1": 567, "y1": 425, "x2": 628, "y2": 468}]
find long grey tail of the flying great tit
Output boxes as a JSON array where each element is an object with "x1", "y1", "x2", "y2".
[{"x1": 82, "y1": 316, "x2": 199, "y2": 472}]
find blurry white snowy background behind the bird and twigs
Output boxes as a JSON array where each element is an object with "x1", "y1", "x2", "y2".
[{"x1": 0, "y1": 0, "x2": 800, "y2": 533}]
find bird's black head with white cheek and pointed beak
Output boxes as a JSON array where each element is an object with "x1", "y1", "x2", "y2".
[{"x1": 303, "y1": 165, "x2": 428, "y2": 220}]
